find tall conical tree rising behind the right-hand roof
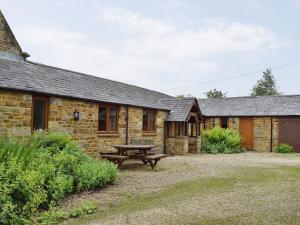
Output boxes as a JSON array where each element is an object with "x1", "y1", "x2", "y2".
[{"x1": 251, "y1": 68, "x2": 279, "y2": 96}]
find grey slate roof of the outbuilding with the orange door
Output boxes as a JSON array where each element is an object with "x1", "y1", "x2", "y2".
[{"x1": 198, "y1": 95, "x2": 300, "y2": 116}]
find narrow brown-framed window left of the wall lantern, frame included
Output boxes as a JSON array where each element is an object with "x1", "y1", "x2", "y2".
[{"x1": 32, "y1": 96, "x2": 48, "y2": 131}]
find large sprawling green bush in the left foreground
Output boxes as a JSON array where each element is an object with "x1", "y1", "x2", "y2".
[{"x1": 0, "y1": 132, "x2": 117, "y2": 225}]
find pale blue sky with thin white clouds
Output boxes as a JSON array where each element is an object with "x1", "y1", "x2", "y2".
[{"x1": 0, "y1": 0, "x2": 300, "y2": 97}]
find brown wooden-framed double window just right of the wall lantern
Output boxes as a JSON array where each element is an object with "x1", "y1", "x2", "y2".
[{"x1": 98, "y1": 106, "x2": 118, "y2": 133}]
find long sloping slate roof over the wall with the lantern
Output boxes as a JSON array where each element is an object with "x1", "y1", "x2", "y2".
[{"x1": 0, "y1": 59, "x2": 173, "y2": 110}]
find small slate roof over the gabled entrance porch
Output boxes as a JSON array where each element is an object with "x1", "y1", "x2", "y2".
[{"x1": 163, "y1": 98, "x2": 197, "y2": 122}]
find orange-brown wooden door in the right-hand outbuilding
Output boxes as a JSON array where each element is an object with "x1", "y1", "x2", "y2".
[{"x1": 240, "y1": 117, "x2": 254, "y2": 150}]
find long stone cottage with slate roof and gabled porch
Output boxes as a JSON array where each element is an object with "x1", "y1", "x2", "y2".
[{"x1": 0, "y1": 11, "x2": 202, "y2": 156}]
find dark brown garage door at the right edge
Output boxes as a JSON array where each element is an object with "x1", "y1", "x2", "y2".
[{"x1": 279, "y1": 118, "x2": 300, "y2": 152}]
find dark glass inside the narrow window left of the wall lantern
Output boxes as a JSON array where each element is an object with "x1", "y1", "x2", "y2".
[{"x1": 33, "y1": 99, "x2": 47, "y2": 130}]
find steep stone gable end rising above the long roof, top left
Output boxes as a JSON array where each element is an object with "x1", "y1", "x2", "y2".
[{"x1": 0, "y1": 10, "x2": 29, "y2": 61}]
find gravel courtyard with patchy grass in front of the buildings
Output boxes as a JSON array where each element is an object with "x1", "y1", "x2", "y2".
[{"x1": 64, "y1": 153, "x2": 300, "y2": 225}]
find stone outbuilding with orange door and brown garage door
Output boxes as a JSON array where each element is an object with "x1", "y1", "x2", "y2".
[{"x1": 198, "y1": 95, "x2": 300, "y2": 152}]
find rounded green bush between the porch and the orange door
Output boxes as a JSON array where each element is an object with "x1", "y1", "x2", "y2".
[{"x1": 202, "y1": 128, "x2": 245, "y2": 154}]
